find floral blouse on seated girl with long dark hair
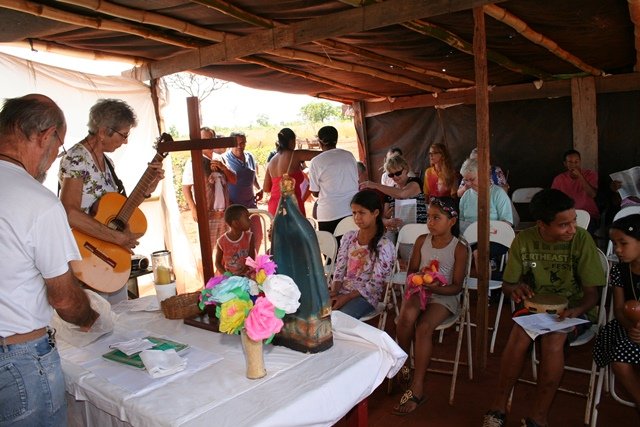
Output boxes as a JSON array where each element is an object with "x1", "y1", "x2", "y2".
[{"x1": 333, "y1": 230, "x2": 396, "y2": 307}]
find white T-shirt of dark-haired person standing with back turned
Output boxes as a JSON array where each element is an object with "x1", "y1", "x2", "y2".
[{"x1": 309, "y1": 148, "x2": 358, "y2": 222}]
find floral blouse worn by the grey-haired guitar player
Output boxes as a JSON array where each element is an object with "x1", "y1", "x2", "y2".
[{"x1": 58, "y1": 142, "x2": 118, "y2": 213}]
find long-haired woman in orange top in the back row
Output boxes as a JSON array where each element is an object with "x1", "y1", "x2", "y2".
[{"x1": 423, "y1": 143, "x2": 458, "y2": 198}]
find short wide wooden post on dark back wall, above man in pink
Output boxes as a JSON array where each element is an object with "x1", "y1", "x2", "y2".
[{"x1": 571, "y1": 77, "x2": 598, "y2": 171}]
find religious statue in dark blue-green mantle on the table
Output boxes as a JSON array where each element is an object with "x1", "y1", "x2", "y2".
[{"x1": 271, "y1": 175, "x2": 333, "y2": 353}]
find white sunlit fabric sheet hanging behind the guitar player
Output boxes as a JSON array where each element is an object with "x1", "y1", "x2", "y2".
[{"x1": 0, "y1": 53, "x2": 202, "y2": 298}]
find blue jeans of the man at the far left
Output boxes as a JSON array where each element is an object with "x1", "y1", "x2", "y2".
[{"x1": 0, "y1": 335, "x2": 67, "y2": 427}]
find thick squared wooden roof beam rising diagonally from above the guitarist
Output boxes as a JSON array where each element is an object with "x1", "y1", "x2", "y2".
[{"x1": 142, "y1": 0, "x2": 500, "y2": 80}]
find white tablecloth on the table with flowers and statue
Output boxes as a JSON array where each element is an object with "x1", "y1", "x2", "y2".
[{"x1": 59, "y1": 297, "x2": 407, "y2": 427}]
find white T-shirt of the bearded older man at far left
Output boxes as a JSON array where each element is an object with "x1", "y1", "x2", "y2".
[{"x1": 0, "y1": 161, "x2": 80, "y2": 337}]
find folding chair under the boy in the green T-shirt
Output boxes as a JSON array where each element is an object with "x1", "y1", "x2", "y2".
[{"x1": 507, "y1": 249, "x2": 609, "y2": 425}]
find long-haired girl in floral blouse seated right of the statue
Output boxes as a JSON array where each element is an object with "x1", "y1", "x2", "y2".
[{"x1": 329, "y1": 190, "x2": 395, "y2": 319}]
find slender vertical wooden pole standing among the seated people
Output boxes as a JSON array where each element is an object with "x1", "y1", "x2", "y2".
[{"x1": 473, "y1": 7, "x2": 490, "y2": 372}]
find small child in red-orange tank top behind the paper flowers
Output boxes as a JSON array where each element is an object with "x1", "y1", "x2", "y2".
[{"x1": 216, "y1": 205, "x2": 256, "y2": 276}]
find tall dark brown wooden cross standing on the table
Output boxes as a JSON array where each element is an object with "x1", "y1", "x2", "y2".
[{"x1": 158, "y1": 96, "x2": 237, "y2": 283}]
